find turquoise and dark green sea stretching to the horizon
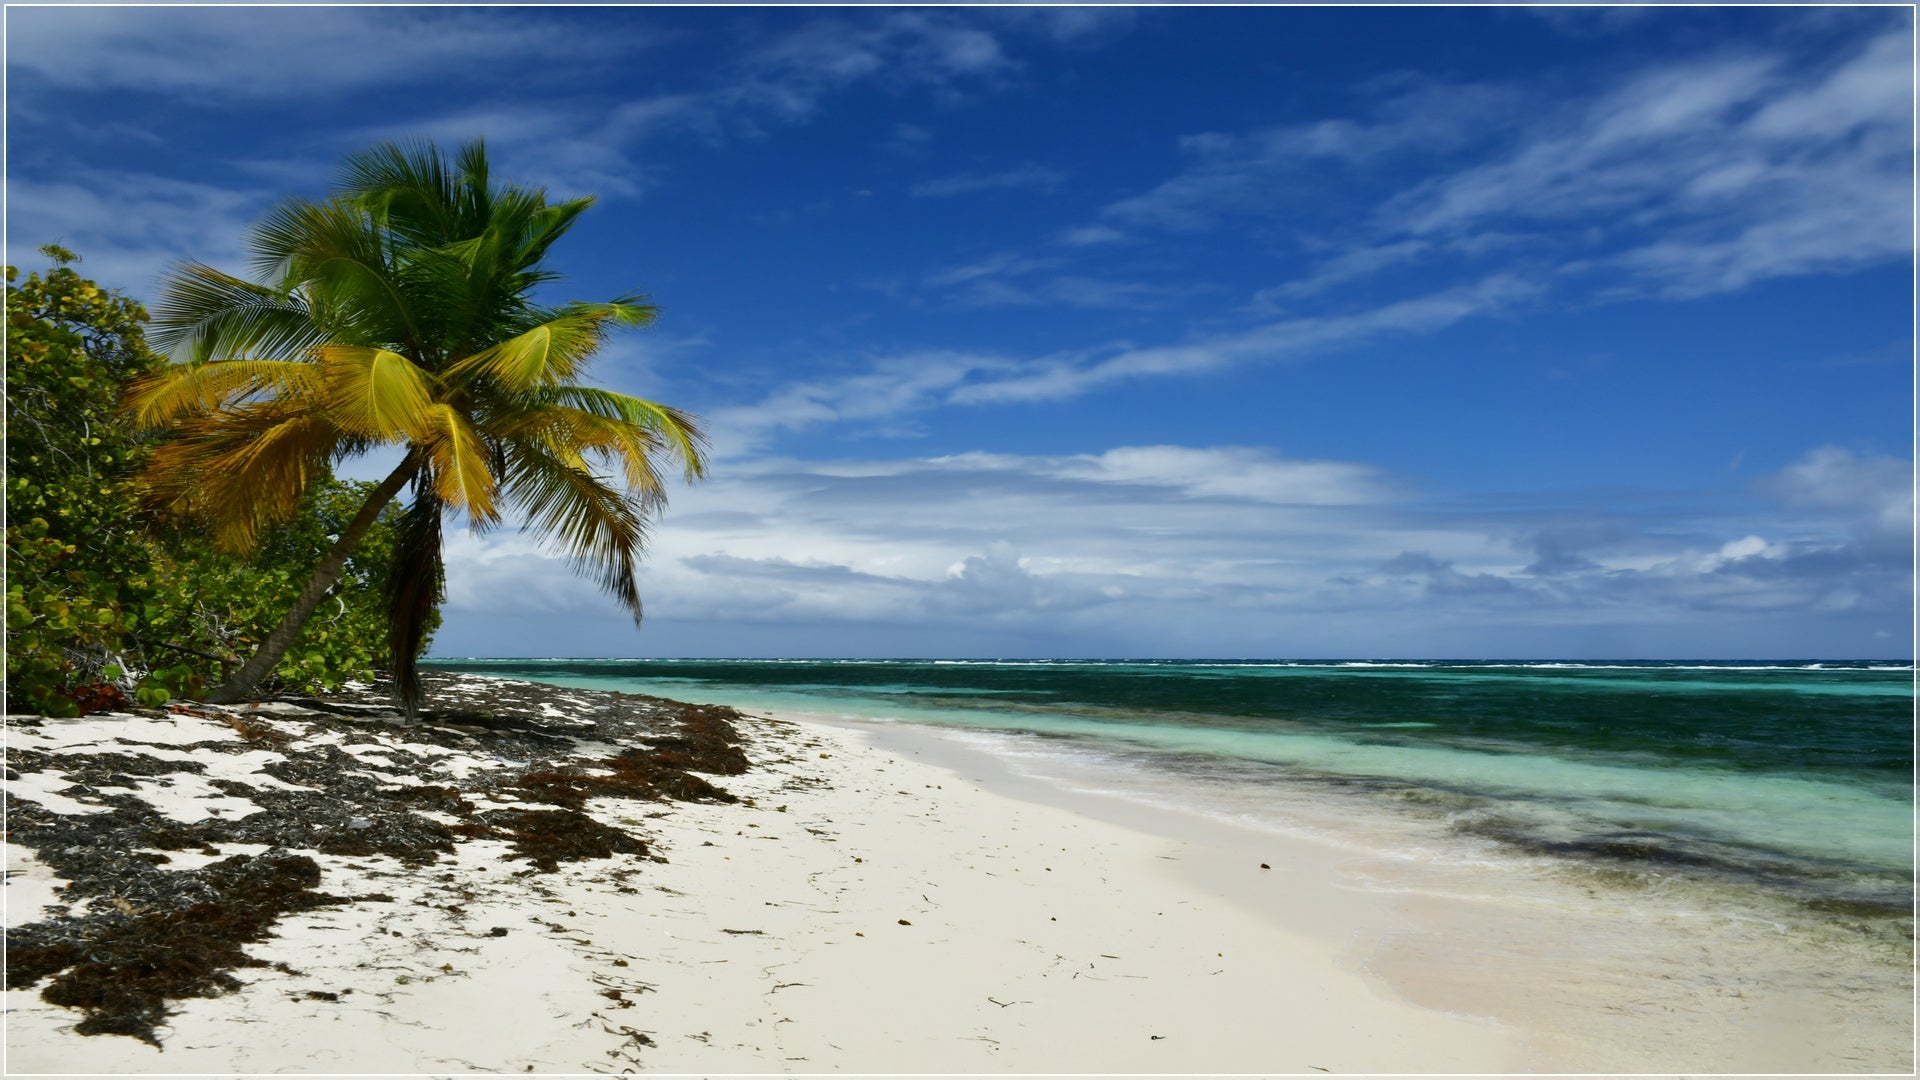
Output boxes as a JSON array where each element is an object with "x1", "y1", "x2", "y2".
[{"x1": 432, "y1": 659, "x2": 1914, "y2": 919}]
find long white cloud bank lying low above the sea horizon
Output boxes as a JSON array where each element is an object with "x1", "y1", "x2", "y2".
[{"x1": 432, "y1": 446, "x2": 1912, "y2": 655}]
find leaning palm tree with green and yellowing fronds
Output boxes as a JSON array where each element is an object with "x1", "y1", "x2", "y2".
[{"x1": 125, "y1": 142, "x2": 705, "y2": 719}]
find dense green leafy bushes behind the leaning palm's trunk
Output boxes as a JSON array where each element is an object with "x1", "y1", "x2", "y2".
[{"x1": 6, "y1": 248, "x2": 424, "y2": 715}]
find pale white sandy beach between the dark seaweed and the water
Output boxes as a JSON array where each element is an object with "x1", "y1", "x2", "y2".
[{"x1": 6, "y1": 676, "x2": 1912, "y2": 1074}]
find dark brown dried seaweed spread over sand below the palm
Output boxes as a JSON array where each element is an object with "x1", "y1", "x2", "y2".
[{"x1": 6, "y1": 673, "x2": 749, "y2": 1045}]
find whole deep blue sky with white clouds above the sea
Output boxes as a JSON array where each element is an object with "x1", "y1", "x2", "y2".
[{"x1": 6, "y1": 8, "x2": 1914, "y2": 657}]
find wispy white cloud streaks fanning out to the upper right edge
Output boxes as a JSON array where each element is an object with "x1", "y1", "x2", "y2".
[{"x1": 1081, "y1": 29, "x2": 1914, "y2": 302}]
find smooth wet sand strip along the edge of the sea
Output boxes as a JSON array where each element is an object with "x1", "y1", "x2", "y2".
[{"x1": 816, "y1": 719, "x2": 1914, "y2": 1074}]
